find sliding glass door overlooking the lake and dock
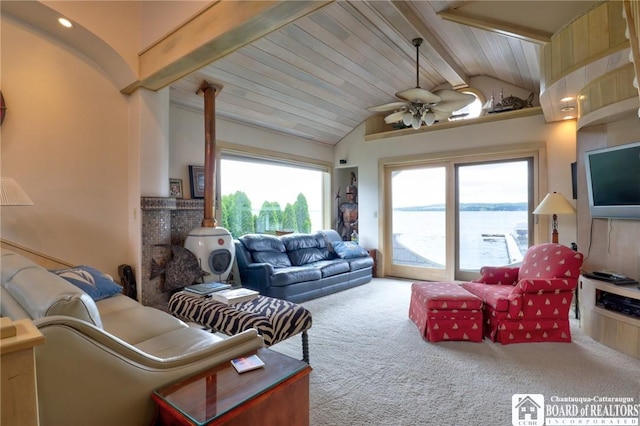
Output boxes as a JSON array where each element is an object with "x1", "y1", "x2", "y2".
[{"x1": 385, "y1": 156, "x2": 534, "y2": 280}]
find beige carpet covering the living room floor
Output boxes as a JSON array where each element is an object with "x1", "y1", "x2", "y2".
[{"x1": 272, "y1": 279, "x2": 640, "y2": 426}]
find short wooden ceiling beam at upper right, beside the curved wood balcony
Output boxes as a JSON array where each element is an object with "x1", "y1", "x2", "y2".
[{"x1": 438, "y1": 9, "x2": 553, "y2": 44}]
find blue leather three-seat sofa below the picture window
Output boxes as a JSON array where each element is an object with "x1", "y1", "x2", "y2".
[{"x1": 235, "y1": 229, "x2": 373, "y2": 302}]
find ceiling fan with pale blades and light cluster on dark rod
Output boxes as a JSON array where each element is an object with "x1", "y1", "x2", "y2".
[{"x1": 367, "y1": 38, "x2": 475, "y2": 130}]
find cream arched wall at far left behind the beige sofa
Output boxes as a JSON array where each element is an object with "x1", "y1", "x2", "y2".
[{"x1": 1, "y1": 15, "x2": 130, "y2": 274}]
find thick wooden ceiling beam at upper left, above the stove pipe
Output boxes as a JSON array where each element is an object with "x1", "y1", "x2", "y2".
[{"x1": 123, "y1": 0, "x2": 333, "y2": 93}]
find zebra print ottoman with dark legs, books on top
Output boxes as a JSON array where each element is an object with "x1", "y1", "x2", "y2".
[{"x1": 169, "y1": 292, "x2": 311, "y2": 363}]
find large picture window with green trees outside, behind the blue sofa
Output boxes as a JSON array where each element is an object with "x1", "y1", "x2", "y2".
[{"x1": 219, "y1": 154, "x2": 327, "y2": 238}]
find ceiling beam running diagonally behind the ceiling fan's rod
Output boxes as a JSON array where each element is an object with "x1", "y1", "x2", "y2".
[{"x1": 364, "y1": 1, "x2": 469, "y2": 88}]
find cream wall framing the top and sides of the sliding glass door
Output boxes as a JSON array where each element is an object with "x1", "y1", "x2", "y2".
[{"x1": 334, "y1": 115, "x2": 576, "y2": 248}]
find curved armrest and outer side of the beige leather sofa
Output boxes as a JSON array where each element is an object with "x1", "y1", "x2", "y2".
[{"x1": 34, "y1": 316, "x2": 263, "y2": 425}]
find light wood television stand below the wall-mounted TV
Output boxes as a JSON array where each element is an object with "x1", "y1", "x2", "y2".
[{"x1": 578, "y1": 275, "x2": 640, "y2": 359}]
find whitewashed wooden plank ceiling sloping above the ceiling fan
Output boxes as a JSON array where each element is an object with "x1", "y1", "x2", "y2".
[{"x1": 170, "y1": 0, "x2": 598, "y2": 145}]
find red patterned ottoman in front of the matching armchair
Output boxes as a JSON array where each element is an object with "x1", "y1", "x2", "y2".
[{"x1": 409, "y1": 282, "x2": 482, "y2": 342}]
